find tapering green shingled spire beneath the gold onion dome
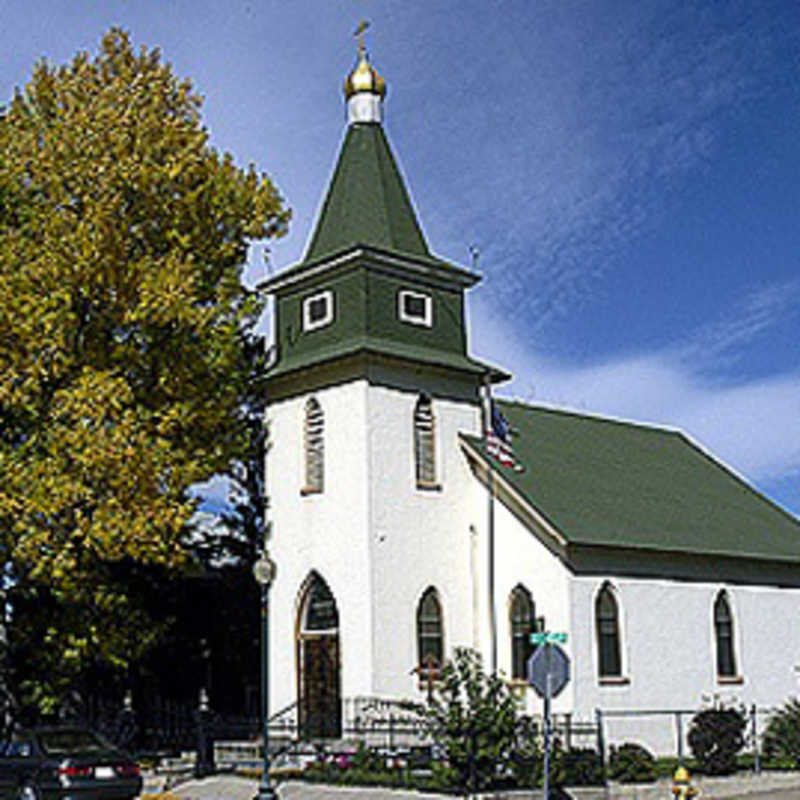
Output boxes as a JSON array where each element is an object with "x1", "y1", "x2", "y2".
[{"x1": 304, "y1": 123, "x2": 430, "y2": 262}]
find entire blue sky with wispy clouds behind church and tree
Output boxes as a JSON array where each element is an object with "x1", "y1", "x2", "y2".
[{"x1": 0, "y1": 0, "x2": 800, "y2": 513}]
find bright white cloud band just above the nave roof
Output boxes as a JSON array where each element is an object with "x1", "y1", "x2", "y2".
[{"x1": 471, "y1": 294, "x2": 800, "y2": 511}]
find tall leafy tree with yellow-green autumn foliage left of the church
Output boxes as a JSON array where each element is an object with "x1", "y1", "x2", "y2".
[{"x1": 0, "y1": 29, "x2": 288, "y2": 708}]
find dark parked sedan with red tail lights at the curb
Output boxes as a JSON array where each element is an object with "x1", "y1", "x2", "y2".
[{"x1": 0, "y1": 727, "x2": 142, "y2": 800}]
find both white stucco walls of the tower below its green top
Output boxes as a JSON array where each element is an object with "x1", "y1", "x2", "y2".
[{"x1": 267, "y1": 380, "x2": 488, "y2": 710}]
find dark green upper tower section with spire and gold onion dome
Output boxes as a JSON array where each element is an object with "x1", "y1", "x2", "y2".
[{"x1": 259, "y1": 48, "x2": 508, "y2": 394}]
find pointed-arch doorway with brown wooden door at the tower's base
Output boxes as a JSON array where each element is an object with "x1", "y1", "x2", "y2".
[{"x1": 297, "y1": 572, "x2": 342, "y2": 739}]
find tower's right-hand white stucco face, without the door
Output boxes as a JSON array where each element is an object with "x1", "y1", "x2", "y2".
[{"x1": 368, "y1": 386, "x2": 480, "y2": 697}]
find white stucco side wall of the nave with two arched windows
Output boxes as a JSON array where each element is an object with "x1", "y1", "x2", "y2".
[{"x1": 571, "y1": 567, "x2": 800, "y2": 754}]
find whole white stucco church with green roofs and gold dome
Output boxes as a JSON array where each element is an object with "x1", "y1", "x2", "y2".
[{"x1": 260, "y1": 43, "x2": 800, "y2": 753}]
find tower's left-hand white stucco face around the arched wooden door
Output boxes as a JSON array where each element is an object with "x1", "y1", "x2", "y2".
[{"x1": 267, "y1": 381, "x2": 372, "y2": 711}]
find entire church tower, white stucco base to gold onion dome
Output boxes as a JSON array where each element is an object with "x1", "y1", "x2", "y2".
[{"x1": 260, "y1": 31, "x2": 507, "y2": 733}]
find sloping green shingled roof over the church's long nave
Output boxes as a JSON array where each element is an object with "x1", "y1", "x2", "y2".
[{"x1": 463, "y1": 401, "x2": 800, "y2": 561}]
